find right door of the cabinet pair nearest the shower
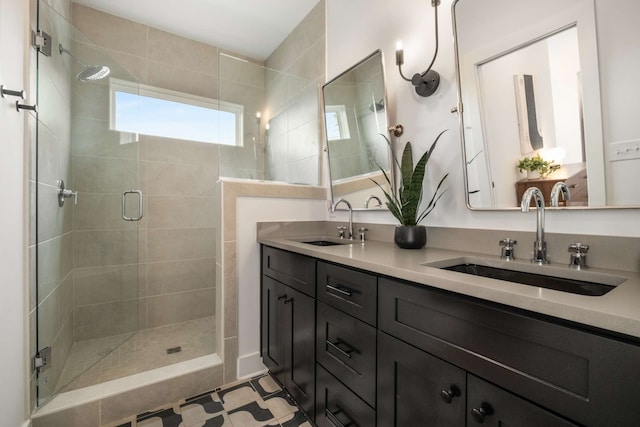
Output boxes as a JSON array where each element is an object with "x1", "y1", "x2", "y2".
[{"x1": 282, "y1": 286, "x2": 316, "y2": 419}]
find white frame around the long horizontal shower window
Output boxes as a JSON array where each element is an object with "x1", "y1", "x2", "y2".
[{"x1": 109, "y1": 77, "x2": 244, "y2": 147}]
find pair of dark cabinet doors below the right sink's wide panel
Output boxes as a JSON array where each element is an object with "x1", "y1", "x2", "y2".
[{"x1": 378, "y1": 332, "x2": 577, "y2": 427}]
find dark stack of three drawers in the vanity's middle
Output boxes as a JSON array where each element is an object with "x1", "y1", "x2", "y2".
[{"x1": 316, "y1": 261, "x2": 378, "y2": 427}]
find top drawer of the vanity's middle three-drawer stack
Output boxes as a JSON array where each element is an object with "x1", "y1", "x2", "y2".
[{"x1": 317, "y1": 261, "x2": 378, "y2": 326}]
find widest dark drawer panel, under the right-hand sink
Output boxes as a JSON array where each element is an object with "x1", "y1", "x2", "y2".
[{"x1": 378, "y1": 279, "x2": 640, "y2": 426}]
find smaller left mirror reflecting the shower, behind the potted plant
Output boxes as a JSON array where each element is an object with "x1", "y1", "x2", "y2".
[{"x1": 322, "y1": 50, "x2": 393, "y2": 210}]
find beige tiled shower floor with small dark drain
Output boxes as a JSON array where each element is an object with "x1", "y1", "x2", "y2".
[{"x1": 58, "y1": 317, "x2": 215, "y2": 391}]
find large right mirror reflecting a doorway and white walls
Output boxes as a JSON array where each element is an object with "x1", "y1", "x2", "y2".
[{"x1": 452, "y1": 0, "x2": 640, "y2": 210}]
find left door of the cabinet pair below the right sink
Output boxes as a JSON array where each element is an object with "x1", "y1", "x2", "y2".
[{"x1": 377, "y1": 332, "x2": 466, "y2": 427}]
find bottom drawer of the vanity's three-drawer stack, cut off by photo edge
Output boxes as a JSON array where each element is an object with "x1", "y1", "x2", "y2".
[{"x1": 316, "y1": 365, "x2": 376, "y2": 427}]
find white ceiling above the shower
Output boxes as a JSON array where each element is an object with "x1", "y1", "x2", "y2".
[{"x1": 73, "y1": 0, "x2": 319, "y2": 60}]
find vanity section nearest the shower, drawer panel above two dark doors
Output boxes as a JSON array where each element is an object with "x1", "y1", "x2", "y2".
[{"x1": 260, "y1": 247, "x2": 315, "y2": 417}]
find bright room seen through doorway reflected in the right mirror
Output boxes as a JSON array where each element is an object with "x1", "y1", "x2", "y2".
[{"x1": 478, "y1": 26, "x2": 588, "y2": 206}]
